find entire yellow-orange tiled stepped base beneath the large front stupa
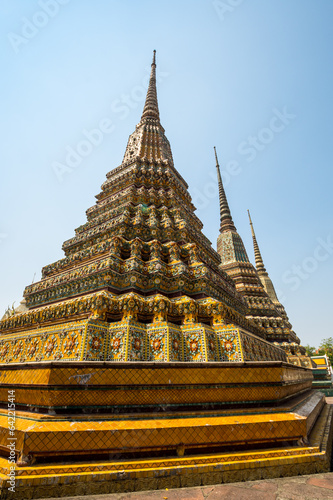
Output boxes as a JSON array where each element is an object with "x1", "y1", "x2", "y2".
[{"x1": 0, "y1": 362, "x2": 332, "y2": 500}]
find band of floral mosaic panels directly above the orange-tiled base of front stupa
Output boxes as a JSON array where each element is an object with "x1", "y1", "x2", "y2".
[{"x1": 0, "y1": 316, "x2": 287, "y2": 363}]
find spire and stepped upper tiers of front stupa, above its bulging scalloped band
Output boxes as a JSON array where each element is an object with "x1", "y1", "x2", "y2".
[{"x1": 24, "y1": 53, "x2": 241, "y2": 313}]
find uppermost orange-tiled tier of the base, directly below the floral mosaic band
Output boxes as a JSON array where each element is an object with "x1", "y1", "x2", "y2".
[{"x1": 0, "y1": 361, "x2": 312, "y2": 412}]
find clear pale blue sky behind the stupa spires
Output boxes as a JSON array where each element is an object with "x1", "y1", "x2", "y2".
[{"x1": 0, "y1": 0, "x2": 333, "y2": 346}]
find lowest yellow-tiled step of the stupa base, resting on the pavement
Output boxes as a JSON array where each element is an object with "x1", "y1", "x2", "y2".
[{"x1": 0, "y1": 405, "x2": 332, "y2": 500}]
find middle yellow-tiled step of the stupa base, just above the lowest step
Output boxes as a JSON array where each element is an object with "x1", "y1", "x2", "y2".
[{"x1": 0, "y1": 413, "x2": 307, "y2": 457}]
